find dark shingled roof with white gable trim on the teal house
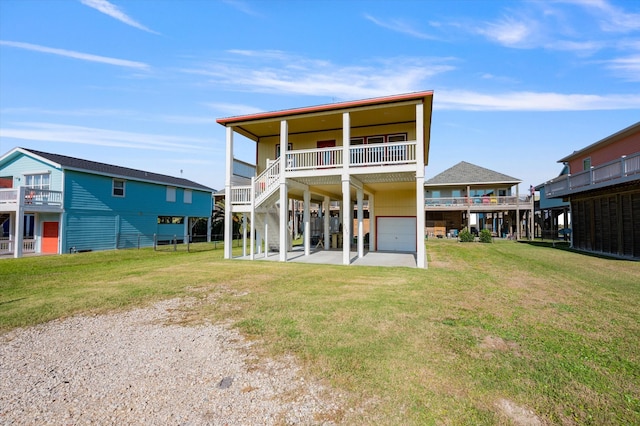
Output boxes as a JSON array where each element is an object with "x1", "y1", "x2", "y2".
[{"x1": 0, "y1": 148, "x2": 214, "y2": 192}]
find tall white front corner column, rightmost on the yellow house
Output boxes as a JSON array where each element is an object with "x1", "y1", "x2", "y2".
[{"x1": 416, "y1": 103, "x2": 427, "y2": 268}]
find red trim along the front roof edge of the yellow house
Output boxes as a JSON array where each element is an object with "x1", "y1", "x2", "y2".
[{"x1": 216, "y1": 90, "x2": 433, "y2": 126}]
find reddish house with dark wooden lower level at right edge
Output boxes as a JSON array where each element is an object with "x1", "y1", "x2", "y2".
[{"x1": 544, "y1": 122, "x2": 640, "y2": 259}]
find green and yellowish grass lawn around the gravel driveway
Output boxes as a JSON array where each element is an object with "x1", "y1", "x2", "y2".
[{"x1": 0, "y1": 240, "x2": 640, "y2": 425}]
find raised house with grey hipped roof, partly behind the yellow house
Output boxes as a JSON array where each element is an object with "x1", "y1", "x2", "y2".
[{"x1": 424, "y1": 161, "x2": 534, "y2": 239}]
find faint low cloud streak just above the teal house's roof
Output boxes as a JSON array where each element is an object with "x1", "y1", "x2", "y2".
[{"x1": 0, "y1": 122, "x2": 211, "y2": 152}]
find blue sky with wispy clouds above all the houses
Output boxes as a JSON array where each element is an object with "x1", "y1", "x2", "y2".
[{"x1": 0, "y1": 0, "x2": 640, "y2": 191}]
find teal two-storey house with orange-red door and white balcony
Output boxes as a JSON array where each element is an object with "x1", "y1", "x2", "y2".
[{"x1": 0, "y1": 148, "x2": 213, "y2": 257}]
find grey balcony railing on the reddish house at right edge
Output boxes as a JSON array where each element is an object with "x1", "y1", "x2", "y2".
[{"x1": 544, "y1": 152, "x2": 640, "y2": 198}]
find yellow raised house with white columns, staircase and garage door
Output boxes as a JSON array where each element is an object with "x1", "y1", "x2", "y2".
[{"x1": 217, "y1": 91, "x2": 433, "y2": 267}]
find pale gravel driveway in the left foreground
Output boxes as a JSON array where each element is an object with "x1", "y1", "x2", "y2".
[{"x1": 0, "y1": 299, "x2": 342, "y2": 425}]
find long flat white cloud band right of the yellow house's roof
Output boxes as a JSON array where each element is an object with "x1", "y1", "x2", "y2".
[{"x1": 433, "y1": 90, "x2": 640, "y2": 111}]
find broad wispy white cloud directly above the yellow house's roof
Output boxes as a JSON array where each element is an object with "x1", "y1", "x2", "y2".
[{"x1": 182, "y1": 51, "x2": 455, "y2": 100}]
